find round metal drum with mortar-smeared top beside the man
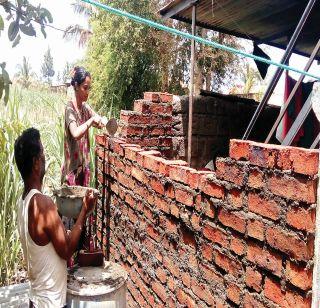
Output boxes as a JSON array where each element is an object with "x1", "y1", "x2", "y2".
[{"x1": 67, "y1": 262, "x2": 128, "y2": 308}]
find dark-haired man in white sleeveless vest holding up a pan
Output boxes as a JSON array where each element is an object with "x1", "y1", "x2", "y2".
[{"x1": 14, "y1": 128, "x2": 96, "y2": 308}]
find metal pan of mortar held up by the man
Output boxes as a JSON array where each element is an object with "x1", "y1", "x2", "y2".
[{"x1": 53, "y1": 186, "x2": 99, "y2": 218}]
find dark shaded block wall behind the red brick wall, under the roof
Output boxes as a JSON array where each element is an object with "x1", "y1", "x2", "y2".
[{"x1": 173, "y1": 93, "x2": 279, "y2": 168}]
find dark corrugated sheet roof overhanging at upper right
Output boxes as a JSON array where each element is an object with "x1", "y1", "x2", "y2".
[{"x1": 160, "y1": 0, "x2": 320, "y2": 59}]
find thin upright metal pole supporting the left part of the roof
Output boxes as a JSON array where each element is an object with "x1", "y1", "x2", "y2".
[{"x1": 188, "y1": 5, "x2": 196, "y2": 166}]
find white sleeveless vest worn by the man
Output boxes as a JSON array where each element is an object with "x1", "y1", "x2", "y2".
[{"x1": 18, "y1": 189, "x2": 67, "y2": 308}]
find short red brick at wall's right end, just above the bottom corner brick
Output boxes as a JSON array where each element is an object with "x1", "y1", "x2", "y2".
[{"x1": 286, "y1": 261, "x2": 312, "y2": 291}]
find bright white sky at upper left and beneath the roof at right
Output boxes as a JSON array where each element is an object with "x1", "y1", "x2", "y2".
[{"x1": 0, "y1": 0, "x2": 320, "y2": 103}]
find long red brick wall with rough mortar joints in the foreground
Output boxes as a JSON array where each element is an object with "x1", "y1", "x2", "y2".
[{"x1": 96, "y1": 92, "x2": 318, "y2": 307}]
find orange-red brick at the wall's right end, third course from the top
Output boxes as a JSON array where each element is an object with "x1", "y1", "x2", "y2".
[{"x1": 286, "y1": 207, "x2": 316, "y2": 233}]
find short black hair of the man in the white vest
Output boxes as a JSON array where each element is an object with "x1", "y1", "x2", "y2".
[{"x1": 14, "y1": 127, "x2": 41, "y2": 180}]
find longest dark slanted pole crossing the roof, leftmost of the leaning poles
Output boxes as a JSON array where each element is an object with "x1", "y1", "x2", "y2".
[{"x1": 242, "y1": 0, "x2": 317, "y2": 140}]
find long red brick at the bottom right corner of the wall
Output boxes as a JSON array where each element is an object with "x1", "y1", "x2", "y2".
[{"x1": 264, "y1": 278, "x2": 311, "y2": 308}]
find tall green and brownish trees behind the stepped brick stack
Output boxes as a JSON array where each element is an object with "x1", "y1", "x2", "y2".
[{"x1": 86, "y1": 0, "x2": 244, "y2": 109}]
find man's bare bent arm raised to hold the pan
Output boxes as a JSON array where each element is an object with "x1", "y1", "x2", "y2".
[{"x1": 44, "y1": 192, "x2": 95, "y2": 260}]
